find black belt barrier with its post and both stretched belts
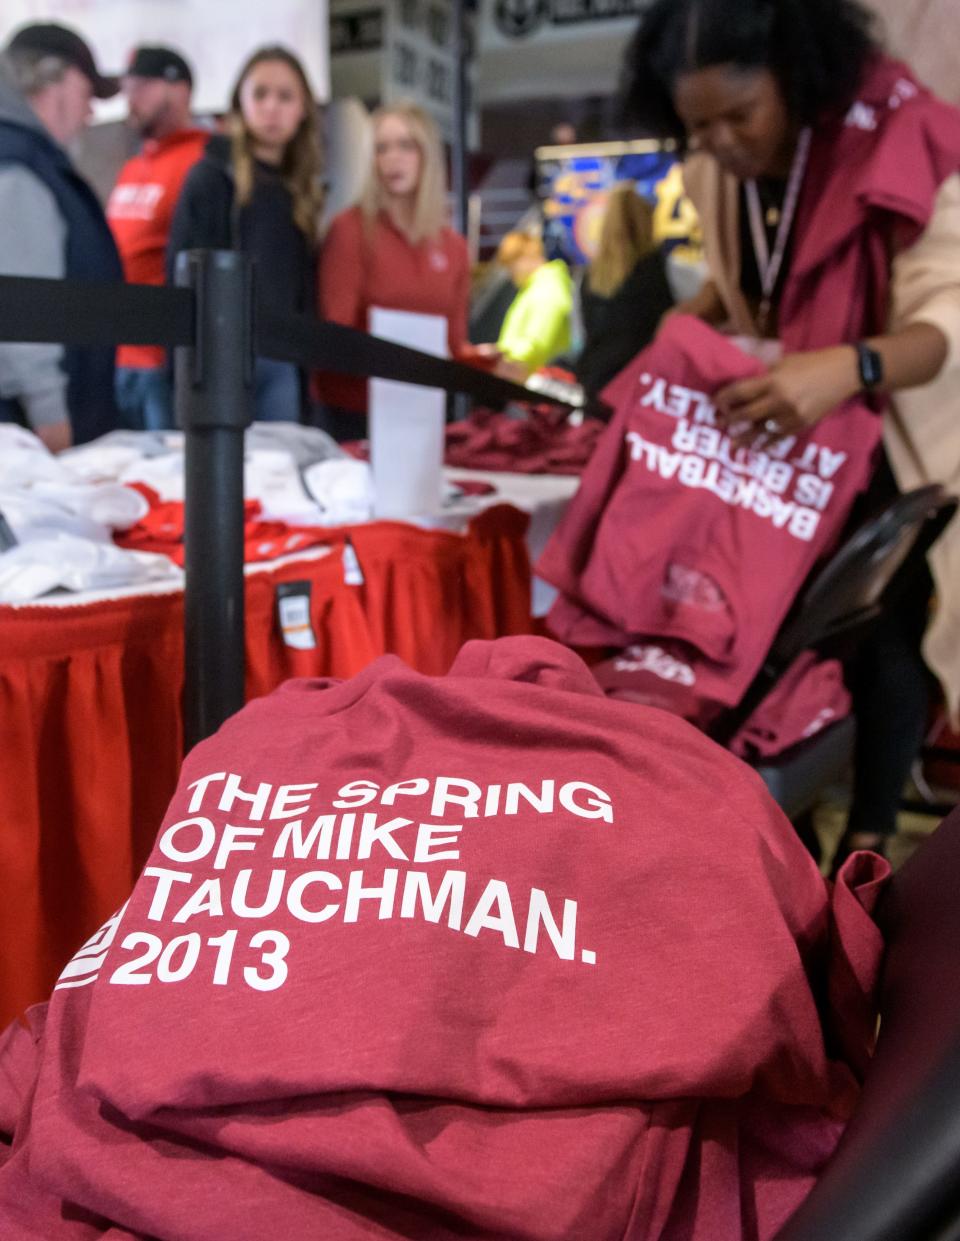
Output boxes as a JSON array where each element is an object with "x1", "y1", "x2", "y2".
[{"x1": 0, "y1": 251, "x2": 573, "y2": 747}]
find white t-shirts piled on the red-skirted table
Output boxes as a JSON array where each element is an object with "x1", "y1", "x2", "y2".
[{"x1": 0, "y1": 423, "x2": 473, "y2": 604}]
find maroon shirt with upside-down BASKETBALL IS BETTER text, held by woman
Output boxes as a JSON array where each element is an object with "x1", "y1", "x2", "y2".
[{"x1": 536, "y1": 315, "x2": 881, "y2": 706}]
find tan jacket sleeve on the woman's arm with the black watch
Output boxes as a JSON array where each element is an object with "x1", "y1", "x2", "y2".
[{"x1": 891, "y1": 172, "x2": 960, "y2": 370}]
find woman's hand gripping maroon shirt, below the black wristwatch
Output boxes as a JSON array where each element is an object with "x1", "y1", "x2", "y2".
[{"x1": 714, "y1": 345, "x2": 861, "y2": 444}]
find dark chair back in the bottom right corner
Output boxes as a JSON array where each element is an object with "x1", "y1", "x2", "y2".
[{"x1": 776, "y1": 808, "x2": 960, "y2": 1241}]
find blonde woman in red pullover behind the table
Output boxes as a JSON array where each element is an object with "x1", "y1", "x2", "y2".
[{"x1": 315, "y1": 103, "x2": 470, "y2": 441}]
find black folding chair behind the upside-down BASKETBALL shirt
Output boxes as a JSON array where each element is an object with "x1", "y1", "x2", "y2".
[{"x1": 708, "y1": 484, "x2": 958, "y2": 822}]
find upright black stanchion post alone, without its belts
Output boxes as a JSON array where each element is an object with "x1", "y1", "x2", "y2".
[{"x1": 175, "y1": 249, "x2": 253, "y2": 747}]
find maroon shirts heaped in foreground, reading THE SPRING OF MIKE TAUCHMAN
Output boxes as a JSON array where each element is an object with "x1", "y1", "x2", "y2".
[{"x1": 0, "y1": 638, "x2": 887, "y2": 1241}]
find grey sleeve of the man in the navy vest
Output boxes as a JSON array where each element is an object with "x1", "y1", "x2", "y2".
[{"x1": 0, "y1": 166, "x2": 68, "y2": 428}]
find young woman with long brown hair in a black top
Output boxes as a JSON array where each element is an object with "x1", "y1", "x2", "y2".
[{"x1": 167, "y1": 46, "x2": 321, "y2": 422}]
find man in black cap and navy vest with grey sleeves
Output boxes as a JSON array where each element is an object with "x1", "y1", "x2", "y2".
[{"x1": 0, "y1": 22, "x2": 123, "y2": 452}]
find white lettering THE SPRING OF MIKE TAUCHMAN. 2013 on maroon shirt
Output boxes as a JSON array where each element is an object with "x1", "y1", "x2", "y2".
[{"x1": 94, "y1": 772, "x2": 614, "y2": 992}]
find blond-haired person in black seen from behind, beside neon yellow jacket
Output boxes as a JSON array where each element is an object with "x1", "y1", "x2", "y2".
[{"x1": 577, "y1": 181, "x2": 673, "y2": 397}]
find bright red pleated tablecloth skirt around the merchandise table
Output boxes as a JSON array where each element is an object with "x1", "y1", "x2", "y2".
[{"x1": 0, "y1": 505, "x2": 531, "y2": 1028}]
